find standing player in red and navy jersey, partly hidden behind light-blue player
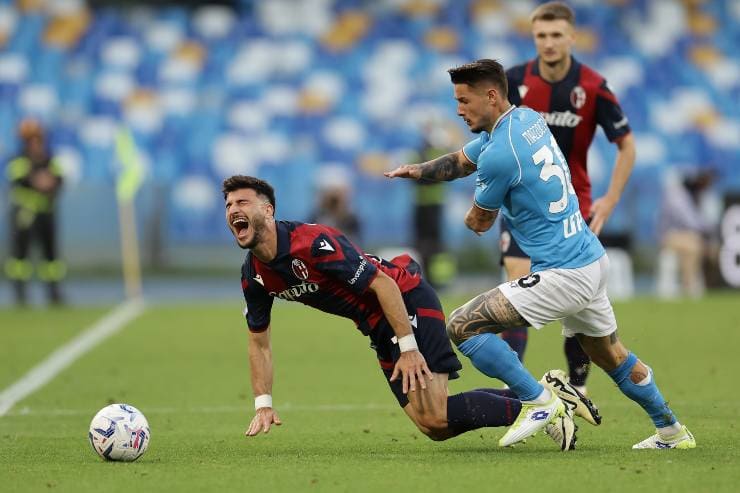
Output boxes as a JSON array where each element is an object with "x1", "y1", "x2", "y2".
[{"x1": 500, "y1": 2, "x2": 635, "y2": 393}]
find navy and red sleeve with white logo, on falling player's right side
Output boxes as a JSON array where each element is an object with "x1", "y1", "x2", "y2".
[{"x1": 311, "y1": 228, "x2": 378, "y2": 294}]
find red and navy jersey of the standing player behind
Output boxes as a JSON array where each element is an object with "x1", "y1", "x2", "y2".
[{"x1": 506, "y1": 58, "x2": 630, "y2": 218}]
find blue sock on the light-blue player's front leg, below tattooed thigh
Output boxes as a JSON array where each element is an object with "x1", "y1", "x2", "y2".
[{"x1": 458, "y1": 333, "x2": 544, "y2": 401}]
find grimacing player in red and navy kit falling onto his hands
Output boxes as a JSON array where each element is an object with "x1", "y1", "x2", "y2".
[{"x1": 223, "y1": 176, "x2": 575, "y2": 450}]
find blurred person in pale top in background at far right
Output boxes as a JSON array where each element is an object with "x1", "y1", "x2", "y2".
[{"x1": 659, "y1": 170, "x2": 717, "y2": 298}]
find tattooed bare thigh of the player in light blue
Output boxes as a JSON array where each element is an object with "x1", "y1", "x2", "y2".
[{"x1": 447, "y1": 288, "x2": 529, "y2": 346}]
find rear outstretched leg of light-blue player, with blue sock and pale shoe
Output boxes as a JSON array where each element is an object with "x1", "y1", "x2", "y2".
[{"x1": 579, "y1": 332, "x2": 696, "y2": 449}]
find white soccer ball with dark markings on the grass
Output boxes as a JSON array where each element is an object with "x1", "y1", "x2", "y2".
[{"x1": 88, "y1": 404, "x2": 151, "y2": 462}]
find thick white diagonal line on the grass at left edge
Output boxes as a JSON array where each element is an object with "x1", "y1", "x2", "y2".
[{"x1": 0, "y1": 300, "x2": 144, "y2": 417}]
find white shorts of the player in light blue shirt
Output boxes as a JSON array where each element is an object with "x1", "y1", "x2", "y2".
[{"x1": 498, "y1": 254, "x2": 617, "y2": 337}]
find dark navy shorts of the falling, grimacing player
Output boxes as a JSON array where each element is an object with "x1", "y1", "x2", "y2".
[{"x1": 370, "y1": 280, "x2": 462, "y2": 407}]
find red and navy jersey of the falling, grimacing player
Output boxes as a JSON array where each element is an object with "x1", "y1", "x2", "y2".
[{"x1": 242, "y1": 221, "x2": 421, "y2": 335}]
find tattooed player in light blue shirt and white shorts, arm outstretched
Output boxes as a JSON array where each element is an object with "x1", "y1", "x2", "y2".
[{"x1": 386, "y1": 60, "x2": 696, "y2": 449}]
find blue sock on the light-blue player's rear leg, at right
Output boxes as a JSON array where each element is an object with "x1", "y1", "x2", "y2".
[{"x1": 608, "y1": 353, "x2": 676, "y2": 428}]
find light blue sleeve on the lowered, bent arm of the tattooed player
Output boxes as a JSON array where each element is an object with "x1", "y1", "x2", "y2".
[{"x1": 475, "y1": 143, "x2": 519, "y2": 211}]
